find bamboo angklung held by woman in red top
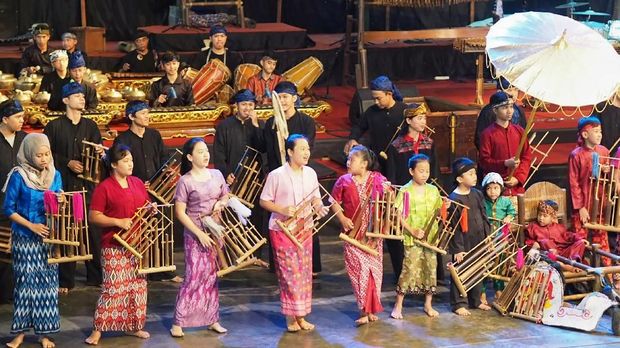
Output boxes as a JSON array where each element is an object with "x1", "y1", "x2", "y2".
[{"x1": 113, "y1": 202, "x2": 176, "y2": 274}]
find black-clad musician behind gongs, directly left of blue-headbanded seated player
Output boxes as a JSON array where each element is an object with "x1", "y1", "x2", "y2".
[{"x1": 40, "y1": 50, "x2": 71, "y2": 111}]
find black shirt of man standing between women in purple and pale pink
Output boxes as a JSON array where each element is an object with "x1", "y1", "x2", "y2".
[{"x1": 213, "y1": 116, "x2": 264, "y2": 178}]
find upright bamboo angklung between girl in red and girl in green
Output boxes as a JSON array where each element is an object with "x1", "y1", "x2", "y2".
[{"x1": 366, "y1": 186, "x2": 405, "y2": 240}]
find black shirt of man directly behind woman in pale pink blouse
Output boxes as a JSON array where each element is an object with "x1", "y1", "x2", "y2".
[{"x1": 255, "y1": 110, "x2": 316, "y2": 172}]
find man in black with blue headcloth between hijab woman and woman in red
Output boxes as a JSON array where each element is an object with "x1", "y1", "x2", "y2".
[{"x1": 43, "y1": 81, "x2": 103, "y2": 293}]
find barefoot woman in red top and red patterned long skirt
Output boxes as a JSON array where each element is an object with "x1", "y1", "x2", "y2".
[{"x1": 85, "y1": 144, "x2": 150, "y2": 345}]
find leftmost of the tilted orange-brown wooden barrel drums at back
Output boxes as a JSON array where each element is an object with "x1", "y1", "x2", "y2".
[{"x1": 192, "y1": 59, "x2": 231, "y2": 105}]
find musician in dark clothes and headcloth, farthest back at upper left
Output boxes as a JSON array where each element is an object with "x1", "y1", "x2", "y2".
[{"x1": 19, "y1": 23, "x2": 52, "y2": 74}]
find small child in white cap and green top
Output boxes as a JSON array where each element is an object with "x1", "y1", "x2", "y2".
[{"x1": 480, "y1": 172, "x2": 517, "y2": 304}]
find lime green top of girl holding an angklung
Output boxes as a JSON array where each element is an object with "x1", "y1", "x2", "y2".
[{"x1": 395, "y1": 181, "x2": 442, "y2": 246}]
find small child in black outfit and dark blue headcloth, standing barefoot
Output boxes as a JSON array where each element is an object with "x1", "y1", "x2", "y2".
[{"x1": 449, "y1": 157, "x2": 491, "y2": 316}]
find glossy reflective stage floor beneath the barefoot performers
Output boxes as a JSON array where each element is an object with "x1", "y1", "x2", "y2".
[{"x1": 0, "y1": 226, "x2": 620, "y2": 348}]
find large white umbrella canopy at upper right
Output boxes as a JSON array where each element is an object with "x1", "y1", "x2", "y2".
[{"x1": 486, "y1": 12, "x2": 620, "y2": 107}]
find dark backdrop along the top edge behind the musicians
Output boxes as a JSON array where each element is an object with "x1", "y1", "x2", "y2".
[{"x1": 0, "y1": 0, "x2": 614, "y2": 40}]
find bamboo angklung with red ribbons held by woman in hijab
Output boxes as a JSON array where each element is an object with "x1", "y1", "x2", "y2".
[{"x1": 43, "y1": 190, "x2": 93, "y2": 264}]
